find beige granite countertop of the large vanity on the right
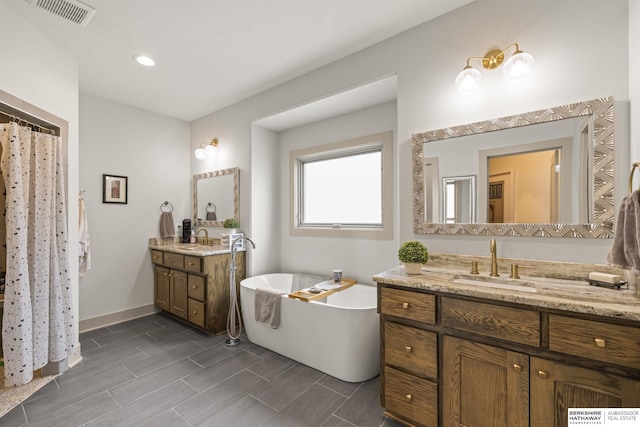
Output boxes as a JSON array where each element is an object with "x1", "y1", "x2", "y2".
[{"x1": 373, "y1": 264, "x2": 640, "y2": 321}]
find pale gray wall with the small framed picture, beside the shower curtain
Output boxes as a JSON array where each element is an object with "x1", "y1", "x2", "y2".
[{"x1": 79, "y1": 94, "x2": 191, "y2": 320}]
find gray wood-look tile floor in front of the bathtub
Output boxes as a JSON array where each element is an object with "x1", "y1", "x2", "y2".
[{"x1": 0, "y1": 315, "x2": 400, "y2": 427}]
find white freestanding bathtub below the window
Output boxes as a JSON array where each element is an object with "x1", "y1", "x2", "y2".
[{"x1": 240, "y1": 273, "x2": 380, "y2": 382}]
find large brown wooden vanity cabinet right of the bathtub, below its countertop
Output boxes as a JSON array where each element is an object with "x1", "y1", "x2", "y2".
[{"x1": 378, "y1": 283, "x2": 640, "y2": 427}]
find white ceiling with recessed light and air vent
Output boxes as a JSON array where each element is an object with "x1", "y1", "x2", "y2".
[{"x1": 0, "y1": 0, "x2": 472, "y2": 123}]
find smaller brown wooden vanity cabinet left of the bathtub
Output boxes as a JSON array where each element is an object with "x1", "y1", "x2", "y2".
[{"x1": 151, "y1": 249, "x2": 245, "y2": 334}]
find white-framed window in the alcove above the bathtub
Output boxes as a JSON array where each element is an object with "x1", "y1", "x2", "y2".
[{"x1": 290, "y1": 132, "x2": 393, "y2": 239}]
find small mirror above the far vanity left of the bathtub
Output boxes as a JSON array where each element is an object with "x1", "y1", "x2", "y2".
[{"x1": 192, "y1": 168, "x2": 240, "y2": 227}]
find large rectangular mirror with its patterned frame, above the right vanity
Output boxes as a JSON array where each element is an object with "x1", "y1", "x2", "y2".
[{"x1": 412, "y1": 98, "x2": 614, "y2": 238}]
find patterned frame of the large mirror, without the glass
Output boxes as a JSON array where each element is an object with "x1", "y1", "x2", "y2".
[{"x1": 411, "y1": 97, "x2": 614, "y2": 238}]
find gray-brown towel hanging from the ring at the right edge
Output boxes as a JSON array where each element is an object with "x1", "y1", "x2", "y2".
[{"x1": 607, "y1": 190, "x2": 640, "y2": 271}]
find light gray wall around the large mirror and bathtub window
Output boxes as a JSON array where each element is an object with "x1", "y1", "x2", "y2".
[{"x1": 192, "y1": 0, "x2": 629, "y2": 288}]
